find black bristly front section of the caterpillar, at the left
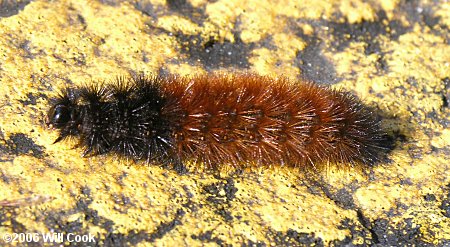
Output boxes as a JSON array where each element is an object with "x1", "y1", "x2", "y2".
[{"x1": 49, "y1": 77, "x2": 172, "y2": 160}]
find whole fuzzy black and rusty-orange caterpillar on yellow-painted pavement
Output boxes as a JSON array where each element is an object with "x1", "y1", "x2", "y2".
[{"x1": 47, "y1": 74, "x2": 390, "y2": 171}]
